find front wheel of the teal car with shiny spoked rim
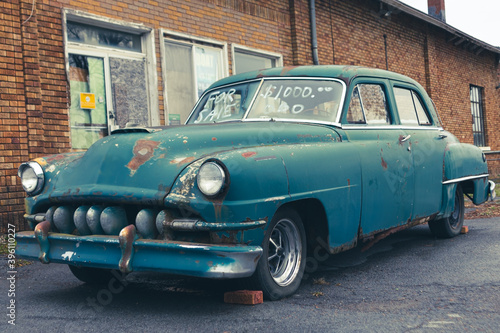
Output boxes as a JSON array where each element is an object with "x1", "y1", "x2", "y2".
[{"x1": 250, "y1": 209, "x2": 306, "y2": 301}]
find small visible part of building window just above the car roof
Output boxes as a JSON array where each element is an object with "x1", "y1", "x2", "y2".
[{"x1": 231, "y1": 45, "x2": 283, "y2": 74}]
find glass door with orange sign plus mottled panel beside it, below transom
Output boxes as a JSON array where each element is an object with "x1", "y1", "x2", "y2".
[{"x1": 68, "y1": 53, "x2": 149, "y2": 149}]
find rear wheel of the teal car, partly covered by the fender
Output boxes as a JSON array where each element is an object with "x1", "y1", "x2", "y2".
[{"x1": 429, "y1": 184, "x2": 465, "y2": 238}]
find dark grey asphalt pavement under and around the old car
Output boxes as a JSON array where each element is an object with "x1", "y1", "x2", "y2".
[{"x1": 0, "y1": 218, "x2": 500, "y2": 332}]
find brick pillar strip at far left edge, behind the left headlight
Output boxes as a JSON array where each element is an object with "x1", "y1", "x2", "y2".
[{"x1": 0, "y1": 1, "x2": 29, "y2": 232}]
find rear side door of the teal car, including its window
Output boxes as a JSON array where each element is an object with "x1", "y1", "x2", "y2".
[{"x1": 393, "y1": 82, "x2": 447, "y2": 219}]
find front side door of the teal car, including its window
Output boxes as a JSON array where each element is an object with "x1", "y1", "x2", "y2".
[{"x1": 342, "y1": 78, "x2": 414, "y2": 236}]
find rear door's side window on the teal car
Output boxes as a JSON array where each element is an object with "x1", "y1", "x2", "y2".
[{"x1": 394, "y1": 87, "x2": 431, "y2": 125}]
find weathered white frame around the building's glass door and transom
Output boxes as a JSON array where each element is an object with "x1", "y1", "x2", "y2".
[{"x1": 62, "y1": 9, "x2": 160, "y2": 131}]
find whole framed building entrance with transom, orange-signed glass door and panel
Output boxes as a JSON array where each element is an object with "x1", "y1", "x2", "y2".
[{"x1": 64, "y1": 10, "x2": 159, "y2": 149}]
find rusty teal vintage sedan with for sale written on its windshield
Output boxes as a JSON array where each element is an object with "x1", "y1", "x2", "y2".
[{"x1": 17, "y1": 66, "x2": 495, "y2": 300}]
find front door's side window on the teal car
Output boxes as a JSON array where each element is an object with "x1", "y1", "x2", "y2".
[{"x1": 347, "y1": 84, "x2": 391, "y2": 125}]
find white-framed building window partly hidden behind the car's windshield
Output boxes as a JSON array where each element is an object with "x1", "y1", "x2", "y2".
[{"x1": 162, "y1": 31, "x2": 228, "y2": 125}]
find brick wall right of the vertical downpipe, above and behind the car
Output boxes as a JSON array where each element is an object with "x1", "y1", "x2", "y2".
[{"x1": 316, "y1": 0, "x2": 500, "y2": 178}]
